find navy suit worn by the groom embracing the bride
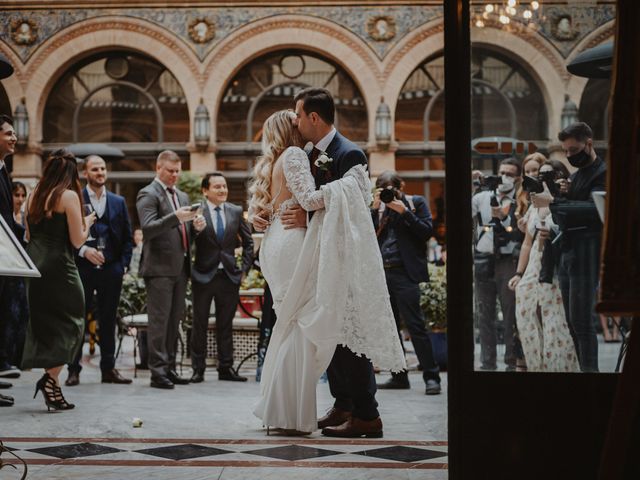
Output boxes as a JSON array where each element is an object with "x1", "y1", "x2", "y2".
[{"x1": 311, "y1": 132, "x2": 380, "y2": 420}]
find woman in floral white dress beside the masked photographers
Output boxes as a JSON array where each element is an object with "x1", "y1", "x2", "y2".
[{"x1": 509, "y1": 162, "x2": 580, "y2": 372}]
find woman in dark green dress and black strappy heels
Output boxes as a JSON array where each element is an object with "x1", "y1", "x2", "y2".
[{"x1": 22, "y1": 149, "x2": 95, "y2": 410}]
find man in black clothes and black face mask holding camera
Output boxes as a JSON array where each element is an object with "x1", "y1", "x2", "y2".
[{"x1": 531, "y1": 122, "x2": 606, "y2": 372}]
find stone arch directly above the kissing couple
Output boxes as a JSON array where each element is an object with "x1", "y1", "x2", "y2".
[{"x1": 203, "y1": 15, "x2": 381, "y2": 145}]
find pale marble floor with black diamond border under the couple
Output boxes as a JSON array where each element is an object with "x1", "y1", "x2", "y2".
[{"x1": 0, "y1": 338, "x2": 447, "y2": 480}]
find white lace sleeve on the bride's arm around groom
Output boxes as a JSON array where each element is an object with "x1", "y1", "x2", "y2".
[{"x1": 283, "y1": 147, "x2": 324, "y2": 212}]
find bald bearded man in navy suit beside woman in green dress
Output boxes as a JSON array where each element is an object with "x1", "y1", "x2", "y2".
[{"x1": 65, "y1": 155, "x2": 133, "y2": 387}]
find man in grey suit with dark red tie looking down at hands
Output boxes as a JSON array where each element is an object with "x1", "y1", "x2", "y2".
[{"x1": 136, "y1": 150, "x2": 196, "y2": 389}]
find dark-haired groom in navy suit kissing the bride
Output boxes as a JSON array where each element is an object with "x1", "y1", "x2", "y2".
[{"x1": 253, "y1": 87, "x2": 382, "y2": 438}]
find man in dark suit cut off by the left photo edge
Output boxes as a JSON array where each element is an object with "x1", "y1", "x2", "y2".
[{"x1": 0, "y1": 115, "x2": 24, "y2": 407}]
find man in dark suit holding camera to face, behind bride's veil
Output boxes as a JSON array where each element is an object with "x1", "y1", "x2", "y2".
[{"x1": 371, "y1": 170, "x2": 441, "y2": 395}]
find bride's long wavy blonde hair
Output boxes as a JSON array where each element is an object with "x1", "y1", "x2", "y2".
[{"x1": 249, "y1": 110, "x2": 303, "y2": 214}]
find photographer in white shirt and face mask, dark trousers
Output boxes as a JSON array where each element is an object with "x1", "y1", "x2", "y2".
[{"x1": 471, "y1": 158, "x2": 522, "y2": 371}]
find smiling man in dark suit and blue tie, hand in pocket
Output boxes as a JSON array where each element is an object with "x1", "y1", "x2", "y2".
[{"x1": 191, "y1": 172, "x2": 253, "y2": 383}]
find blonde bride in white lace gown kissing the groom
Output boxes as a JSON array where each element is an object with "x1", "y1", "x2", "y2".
[{"x1": 249, "y1": 110, "x2": 404, "y2": 435}]
